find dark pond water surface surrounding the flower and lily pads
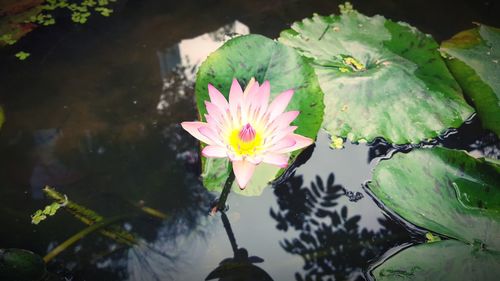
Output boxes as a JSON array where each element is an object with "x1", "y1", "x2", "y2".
[{"x1": 0, "y1": 0, "x2": 500, "y2": 281}]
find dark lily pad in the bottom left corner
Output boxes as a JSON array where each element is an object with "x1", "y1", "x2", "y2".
[{"x1": 0, "y1": 249, "x2": 47, "y2": 281}]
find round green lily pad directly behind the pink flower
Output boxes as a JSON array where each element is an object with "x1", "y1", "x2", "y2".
[{"x1": 195, "y1": 35, "x2": 324, "y2": 196}]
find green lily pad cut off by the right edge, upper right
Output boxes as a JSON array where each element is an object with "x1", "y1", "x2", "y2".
[{"x1": 441, "y1": 25, "x2": 500, "y2": 135}]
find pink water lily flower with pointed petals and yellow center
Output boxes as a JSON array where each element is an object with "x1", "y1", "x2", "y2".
[{"x1": 181, "y1": 78, "x2": 313, "y2": 189}]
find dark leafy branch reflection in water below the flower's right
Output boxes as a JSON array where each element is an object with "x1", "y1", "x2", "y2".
[{"x1": 271, "y1": 173, "x2": 409, "y2": 281}]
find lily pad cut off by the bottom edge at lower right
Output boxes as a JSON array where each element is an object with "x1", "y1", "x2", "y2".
[{"x1": 371, "y1": 240, "x2": 500, "y2": 281}]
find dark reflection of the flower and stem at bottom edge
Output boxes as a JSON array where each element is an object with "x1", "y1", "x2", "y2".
[{"x1": 205, "y1": 212, "x2": 273, "y2": 281}]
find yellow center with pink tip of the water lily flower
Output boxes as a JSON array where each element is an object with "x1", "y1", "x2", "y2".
[{"x1": 229, "y1": 124, "x2": 262, "y2": 156}]
